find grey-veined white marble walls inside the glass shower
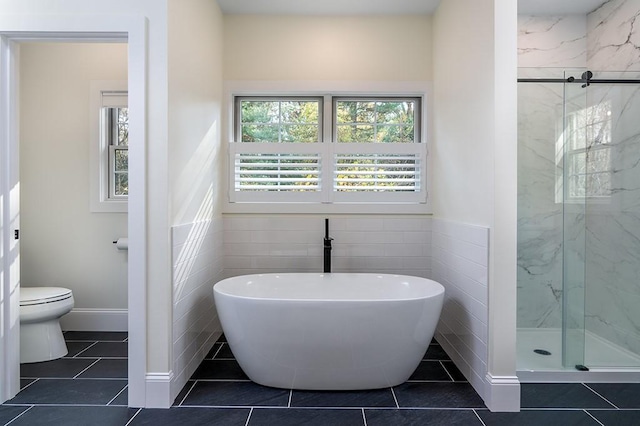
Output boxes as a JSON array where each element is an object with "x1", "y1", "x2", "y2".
[{"x1": 518, "y1": 0, "x2": 640, "y2": 360}]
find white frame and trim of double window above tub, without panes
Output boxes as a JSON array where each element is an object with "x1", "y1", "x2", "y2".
[{"x1": 223, "y1": 81, "x2": 431, "y2": 214}]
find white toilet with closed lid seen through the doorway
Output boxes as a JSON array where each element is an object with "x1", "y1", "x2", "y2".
[{"x1": 20, "y1": 287, "x2": 73, "y2": 363}]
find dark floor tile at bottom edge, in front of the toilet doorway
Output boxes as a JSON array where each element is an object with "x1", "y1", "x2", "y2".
[{"x1": 11, "y1": 406, "x2": 138, "y2": 426}]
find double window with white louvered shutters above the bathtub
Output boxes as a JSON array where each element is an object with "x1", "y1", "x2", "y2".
[{"x1": 230, "y1": 95, "x2": 426, "y2": 203}]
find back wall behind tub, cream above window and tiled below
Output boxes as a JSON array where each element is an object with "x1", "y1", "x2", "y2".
[{"x1": 223, "y1": 15, "x2": 432, "y2": 282}]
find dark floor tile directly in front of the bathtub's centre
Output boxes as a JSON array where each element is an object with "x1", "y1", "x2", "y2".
[{"x1": 291, "y1": 388, "x2": 396, "y2": 408}]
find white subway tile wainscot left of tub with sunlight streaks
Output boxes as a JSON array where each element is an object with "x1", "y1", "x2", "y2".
[{"x1": 171, "y1": 217, "x2": 223, "y2": 397}]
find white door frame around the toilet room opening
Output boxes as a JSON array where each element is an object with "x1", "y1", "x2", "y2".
[{"x1": 0, "y1": 15, "x2": 148, "y2": 407}]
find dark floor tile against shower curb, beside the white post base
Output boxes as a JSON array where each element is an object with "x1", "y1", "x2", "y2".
[{"x1": 520, "y1": 383, "x2": 614, "y2": 408}]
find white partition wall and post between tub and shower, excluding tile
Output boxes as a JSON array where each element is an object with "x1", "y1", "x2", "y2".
[{"x1": 432, "y1": 0, "x2": 520, "y2": 411}]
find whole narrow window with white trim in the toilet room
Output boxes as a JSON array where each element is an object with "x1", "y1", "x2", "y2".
[{"x1": 90, "y1": 81, "x2": 129, "y2": 212}]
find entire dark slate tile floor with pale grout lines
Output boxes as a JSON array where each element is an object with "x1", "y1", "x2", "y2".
[{"x1": 0, "y1": 332, "x2": 640, "y2": 426}]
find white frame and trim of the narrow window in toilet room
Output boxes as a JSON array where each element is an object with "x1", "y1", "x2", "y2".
[{"x1": 89, "y1": 80, "x2": 128, "y2": 213}]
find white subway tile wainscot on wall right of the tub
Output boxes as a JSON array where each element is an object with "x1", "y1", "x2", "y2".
[{"x1": 432, "y1": 219, "x2": 489, "y2": 404}]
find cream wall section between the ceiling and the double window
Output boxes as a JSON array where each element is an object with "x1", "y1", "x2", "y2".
[{"x1": 224, "y1": 15, "x2": 431, "y2": 81}]
